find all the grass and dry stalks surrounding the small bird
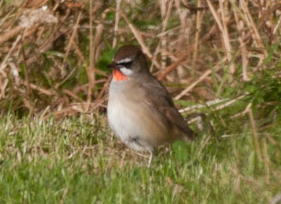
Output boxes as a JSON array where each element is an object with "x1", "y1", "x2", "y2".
[{"x1": 0, "y1": 0, "x2": 281, "y2": 204}]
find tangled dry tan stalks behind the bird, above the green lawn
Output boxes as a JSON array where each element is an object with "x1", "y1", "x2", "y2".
[{"x1": 0, "y1": 0, "x2": 281, "y2": 116}]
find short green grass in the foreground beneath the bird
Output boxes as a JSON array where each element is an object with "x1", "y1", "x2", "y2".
[{"x1": 0, "y1": 111, "x2": 281, "y2": 204}]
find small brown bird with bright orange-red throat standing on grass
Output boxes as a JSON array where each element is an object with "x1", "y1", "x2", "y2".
[{"x1": 107, "y1": 45, "x2": 195, "y2": 167}]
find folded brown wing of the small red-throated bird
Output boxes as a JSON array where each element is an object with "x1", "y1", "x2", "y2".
[{"x1": 140, "y1": 75, "x2": 194, "y2": 139}]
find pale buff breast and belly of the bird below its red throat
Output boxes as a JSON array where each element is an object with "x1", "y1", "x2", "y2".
[{"x1": 107, "y1": 81, "x2": 169, "y2": 151}]
